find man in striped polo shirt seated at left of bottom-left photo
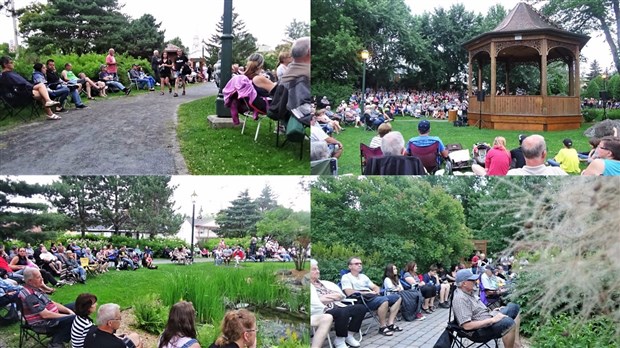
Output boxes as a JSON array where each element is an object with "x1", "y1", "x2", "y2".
[{"x1": 18, "y1": 267, "x2": 75, "y2": 347}]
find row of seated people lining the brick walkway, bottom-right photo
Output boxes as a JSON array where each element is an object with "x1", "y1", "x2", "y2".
[{"x1": 310, "y1": 251, "x2": 519, "y2": 348}]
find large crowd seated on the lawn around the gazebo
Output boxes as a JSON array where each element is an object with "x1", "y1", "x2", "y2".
[{"x1": 310, "y1": 91, "x2": 620, "y2": 176}]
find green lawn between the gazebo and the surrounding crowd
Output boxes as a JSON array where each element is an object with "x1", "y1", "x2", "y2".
[{"x1": 334, "y1": 117, "x2": 592, "y2": 175}]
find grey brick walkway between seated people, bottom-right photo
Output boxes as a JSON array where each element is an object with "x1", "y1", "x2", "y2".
[{"x1": 323, "y1": 308, "x2": 504, "y2": 348}]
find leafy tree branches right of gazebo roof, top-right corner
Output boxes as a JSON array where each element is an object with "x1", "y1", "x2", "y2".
[{"x1": 529, "y1": 0, "x2": 620, "y2": 71}]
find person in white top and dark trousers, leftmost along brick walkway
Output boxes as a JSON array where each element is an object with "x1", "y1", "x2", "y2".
[{"x1": 310, "y1": 259, "x2": 366, "y2": 348}]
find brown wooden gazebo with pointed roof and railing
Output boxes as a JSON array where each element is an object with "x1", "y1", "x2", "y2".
[{"x1": 463, "y1": 2, "x2": 590, "y2": 131}]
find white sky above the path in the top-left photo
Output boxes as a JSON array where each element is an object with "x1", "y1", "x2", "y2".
[{"x1": 0, "y1": 0, "x2": 310, "y2": 53}]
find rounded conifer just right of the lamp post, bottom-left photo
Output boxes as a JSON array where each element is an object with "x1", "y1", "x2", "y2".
[{"x1": 215, "y1": 189, "x2": 261, "y2": 238}]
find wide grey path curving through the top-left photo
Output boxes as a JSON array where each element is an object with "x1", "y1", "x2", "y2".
[{"x1": 0, "y1": 82, "x2": 217, "y2": 175}]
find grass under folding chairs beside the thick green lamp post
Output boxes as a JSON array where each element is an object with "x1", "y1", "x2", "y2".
[{"x1": 177, "y1": 96, "x2": 310, "y2": 175}]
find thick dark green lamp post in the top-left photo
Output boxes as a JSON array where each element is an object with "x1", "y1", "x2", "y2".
[{"x1": 215, "y1": 0, "x2": 233, "y2": 117}]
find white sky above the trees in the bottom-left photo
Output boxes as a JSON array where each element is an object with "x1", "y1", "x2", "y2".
[{"x1": 10, "y1": 175, "x2": 310, "y2": 216}]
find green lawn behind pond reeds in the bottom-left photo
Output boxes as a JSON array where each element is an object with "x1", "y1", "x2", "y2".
[{"x1": 0, "y1": 262, "x2": 308, "y2": 348}]
